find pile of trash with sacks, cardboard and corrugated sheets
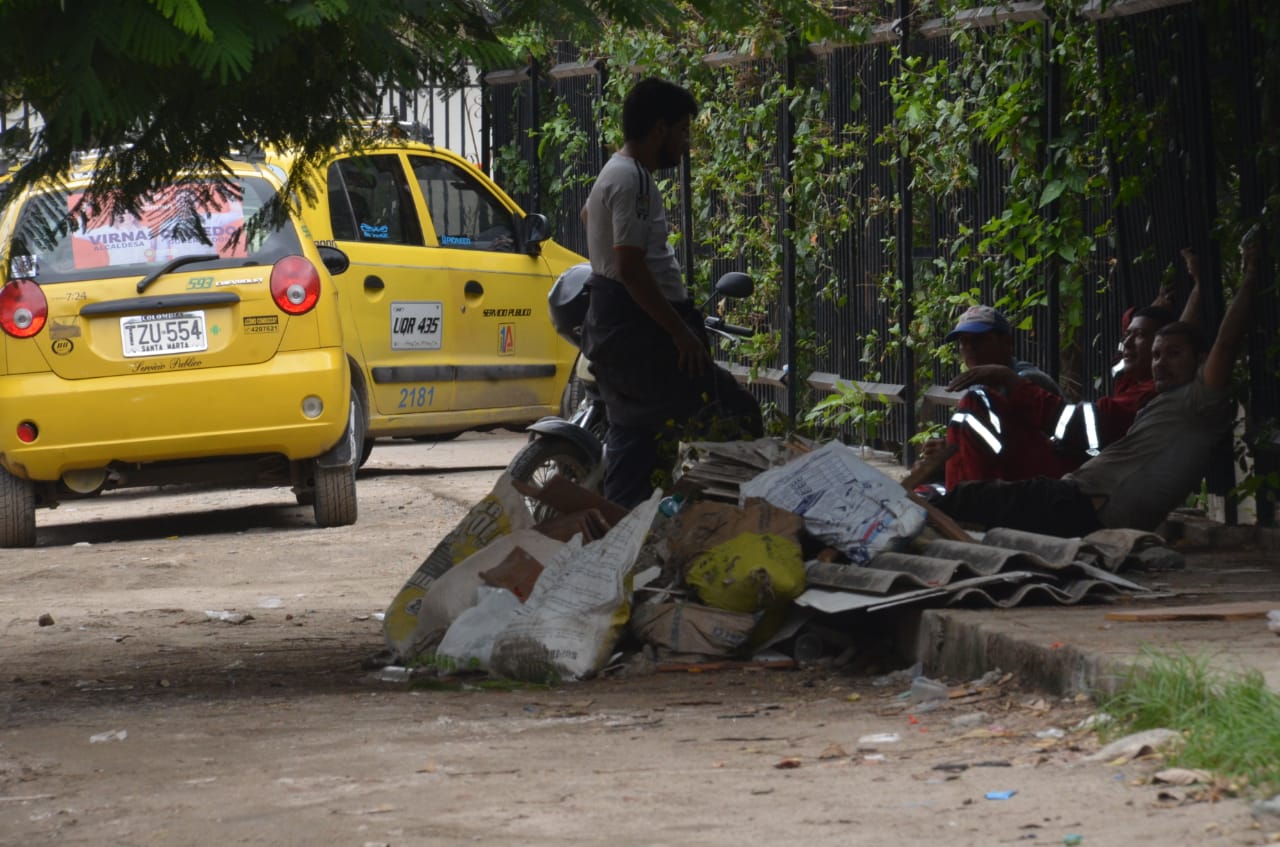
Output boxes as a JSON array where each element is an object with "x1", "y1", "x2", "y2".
[{"x1": 384, "y1": 439, "x2": 1171, "y2": 682}]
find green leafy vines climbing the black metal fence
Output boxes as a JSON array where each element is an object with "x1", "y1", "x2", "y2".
[{"x1": 502, "y1": 0, "x2": 1280, "y2": 498}]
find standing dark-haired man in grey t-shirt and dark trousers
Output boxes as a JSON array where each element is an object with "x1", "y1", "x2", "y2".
[{"x1": 582, "y1": 77, "x2": 764, "y2": 508}]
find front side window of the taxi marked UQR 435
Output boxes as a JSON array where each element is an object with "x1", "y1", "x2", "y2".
[{"x1": 410, "y1": 156, "x2": 516, "y2": 253}]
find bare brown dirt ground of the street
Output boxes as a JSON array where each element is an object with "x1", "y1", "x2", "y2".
[{"x1": 0, "y1": 434, "x2": 1280, "y2": 847}]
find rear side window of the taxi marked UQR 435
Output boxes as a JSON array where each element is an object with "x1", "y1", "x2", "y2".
[{"x1": 328, "y1": 156, "x2": 422, "y2": 246}]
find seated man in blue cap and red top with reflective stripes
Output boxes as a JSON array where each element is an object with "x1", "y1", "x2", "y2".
[{"x1": 925, "y1": 306, "x2": 1066, "y2": 490}]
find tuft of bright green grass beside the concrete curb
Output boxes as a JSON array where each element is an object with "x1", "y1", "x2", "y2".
[{"x1": 1102, "y1": 649, "x2": 1280, "y2": 792}]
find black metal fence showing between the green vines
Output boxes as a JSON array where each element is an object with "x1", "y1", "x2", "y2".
[{"x1": 473, "y1": 0, "x2": 1280, "y2": 519}]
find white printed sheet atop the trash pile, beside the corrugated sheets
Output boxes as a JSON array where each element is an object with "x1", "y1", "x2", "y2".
[{"x1": 739, "y1": 441, "x2": 925, "y2": 564}]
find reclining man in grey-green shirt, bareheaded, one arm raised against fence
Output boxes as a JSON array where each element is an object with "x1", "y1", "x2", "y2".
[{"x1": 934, "y1": 235, "x2": 1262, "y2": 537}]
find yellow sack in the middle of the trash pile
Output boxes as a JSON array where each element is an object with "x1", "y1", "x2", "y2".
[{"x1": 685, "y1": 532, "x2": 804, "y2": 612}]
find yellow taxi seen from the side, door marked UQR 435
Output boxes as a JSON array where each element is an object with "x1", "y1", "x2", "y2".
[{"x1": 280, "y1": 139, "x2": 585, "y2": 458}]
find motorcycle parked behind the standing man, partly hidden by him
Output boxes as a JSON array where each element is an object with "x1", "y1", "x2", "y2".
[{"x1": 507, "y1": 264, "x2": 755, "y2": 521}]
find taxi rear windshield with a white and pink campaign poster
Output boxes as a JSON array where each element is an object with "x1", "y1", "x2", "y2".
[{"x1": 9, "y1": 177, "x2": 301, "y2": 284}]
